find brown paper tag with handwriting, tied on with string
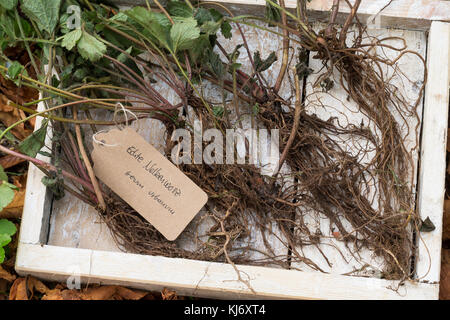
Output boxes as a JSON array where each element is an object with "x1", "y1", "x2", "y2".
[{"x1": 92, "y1": 128, "x2": 208, "y2": 241}]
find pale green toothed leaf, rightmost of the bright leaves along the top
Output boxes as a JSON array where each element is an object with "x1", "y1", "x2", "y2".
[{"x1": 170, "y1": 18, "x2": 200, "y2": 53}]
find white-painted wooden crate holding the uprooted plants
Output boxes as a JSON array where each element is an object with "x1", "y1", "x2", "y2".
[{"x1": 16, "y1": 0, "x2": 450, "y2": 299}]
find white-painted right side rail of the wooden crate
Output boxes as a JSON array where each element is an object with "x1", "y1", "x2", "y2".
[{"x1": 417, "y1": 22, "x2": 450, "y2": 282}]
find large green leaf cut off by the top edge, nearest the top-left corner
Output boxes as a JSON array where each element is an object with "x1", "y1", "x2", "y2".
[{"x1": 21, "y1": 0, "x2": 61, "y2": 33}]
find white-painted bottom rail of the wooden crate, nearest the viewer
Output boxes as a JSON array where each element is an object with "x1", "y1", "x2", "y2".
[{"x1": 16, "y1": 244, "x2": 437, "y2": 300}]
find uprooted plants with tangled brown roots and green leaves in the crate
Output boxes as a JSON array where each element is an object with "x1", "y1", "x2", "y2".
[{"x1": 0, "y1": 0, "x2": 424, "y2": 279}]
